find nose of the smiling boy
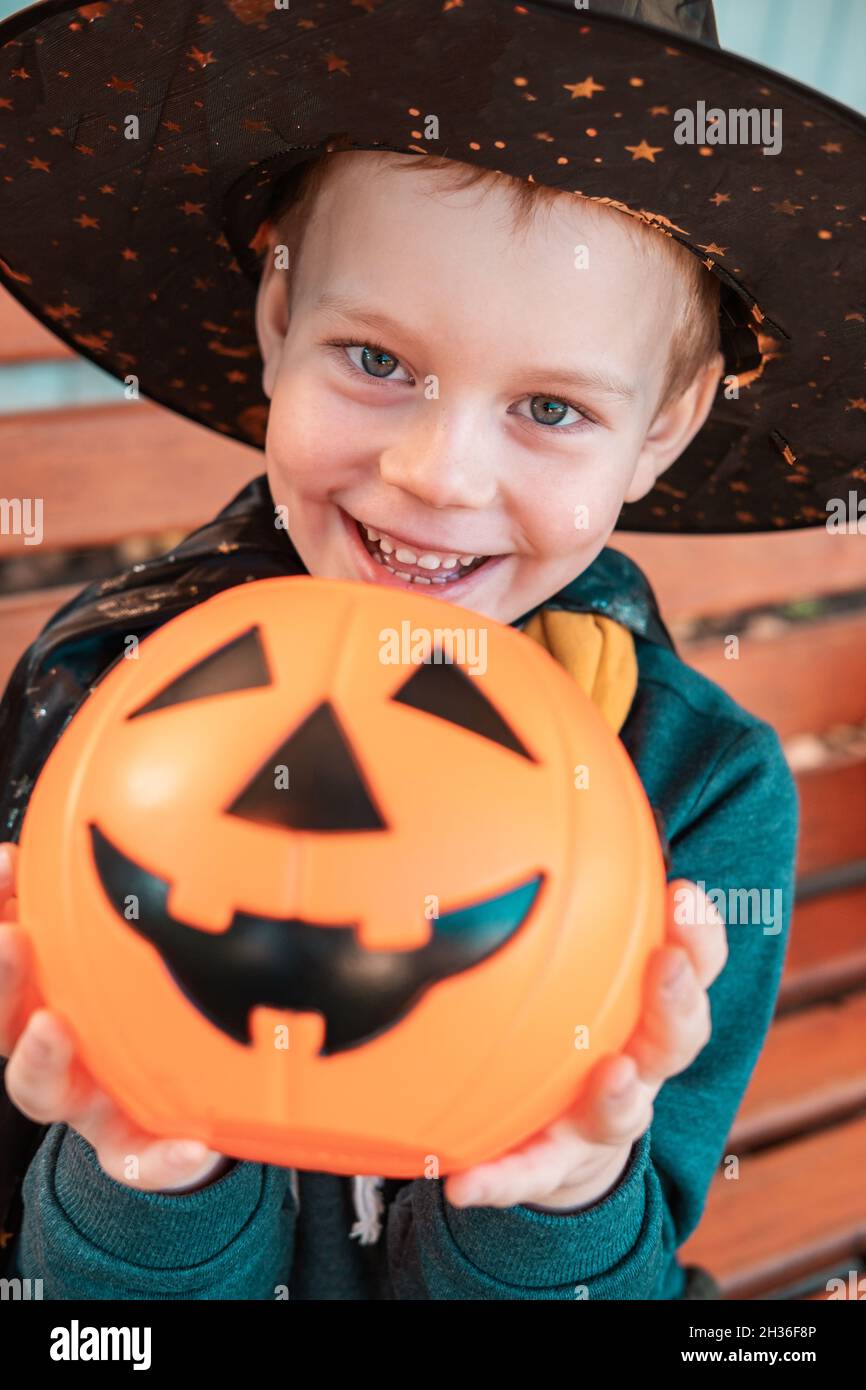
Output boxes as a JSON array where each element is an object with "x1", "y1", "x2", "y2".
[{"x1": 379, "y1": 406, "x2": 499, "y2": 510}]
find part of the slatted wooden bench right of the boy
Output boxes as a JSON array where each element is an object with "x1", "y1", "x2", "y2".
[{"x1": 612, "y1": 528, "x2": 866, "y2": 1298}]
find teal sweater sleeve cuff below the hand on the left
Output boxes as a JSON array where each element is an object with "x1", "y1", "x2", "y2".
[{"x1": 14, "y1": 1125, "x2": 296, "y2": 1300}]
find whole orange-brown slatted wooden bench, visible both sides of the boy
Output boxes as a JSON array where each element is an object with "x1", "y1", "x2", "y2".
[{"x1": 0, "y1": 293, "x2": 866, "y2": 1298}]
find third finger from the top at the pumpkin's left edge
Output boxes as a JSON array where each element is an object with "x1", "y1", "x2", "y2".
[{"x1": 6, "y1": 1009, "x2": 88, "y2": 1125}]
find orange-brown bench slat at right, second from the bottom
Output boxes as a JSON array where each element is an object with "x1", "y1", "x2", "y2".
[{"x1": 728, "y1": 991, "x2": 866, "y2": 1154}]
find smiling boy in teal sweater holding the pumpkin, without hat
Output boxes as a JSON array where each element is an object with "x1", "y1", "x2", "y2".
[{"x1": 0, "y1": 0, "x2": 856, "y2": 1300}]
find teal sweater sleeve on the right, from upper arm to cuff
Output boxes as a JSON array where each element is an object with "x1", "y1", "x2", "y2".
[{"x1": 384, "y1": 723, "x2": 799, "y2": 1300}]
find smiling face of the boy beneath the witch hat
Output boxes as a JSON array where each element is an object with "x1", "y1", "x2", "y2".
[{"x1": 257, "y1": 153, "x2": 719, "y2": 623}]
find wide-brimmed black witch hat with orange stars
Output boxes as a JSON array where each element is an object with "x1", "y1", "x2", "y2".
[{"x1": 0, "y1": 0, "x2": 866, "y2": 532}]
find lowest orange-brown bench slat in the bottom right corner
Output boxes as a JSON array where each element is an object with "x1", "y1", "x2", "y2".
[{"x1": 680, "y1": 1112, "x2": 866, "y2": 1298}]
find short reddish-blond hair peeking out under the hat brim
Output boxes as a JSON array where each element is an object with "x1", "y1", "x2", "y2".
[{"x1": 268, "y1": 148, "x2": 720, "y2": 413}]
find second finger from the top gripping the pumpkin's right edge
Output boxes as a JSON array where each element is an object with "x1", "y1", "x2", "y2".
[{"x1": 627, "y1": 947, "x2": 712, "y2": 1093}]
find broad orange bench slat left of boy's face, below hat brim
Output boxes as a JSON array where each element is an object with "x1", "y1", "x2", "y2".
[{"x1": 0, "y1": 400, "x2": 258, "y2": 556}]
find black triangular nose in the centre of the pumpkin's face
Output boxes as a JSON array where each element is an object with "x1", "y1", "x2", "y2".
[{"x1": 227, "y1": 703, "x2": 388, "y2": 830}]
